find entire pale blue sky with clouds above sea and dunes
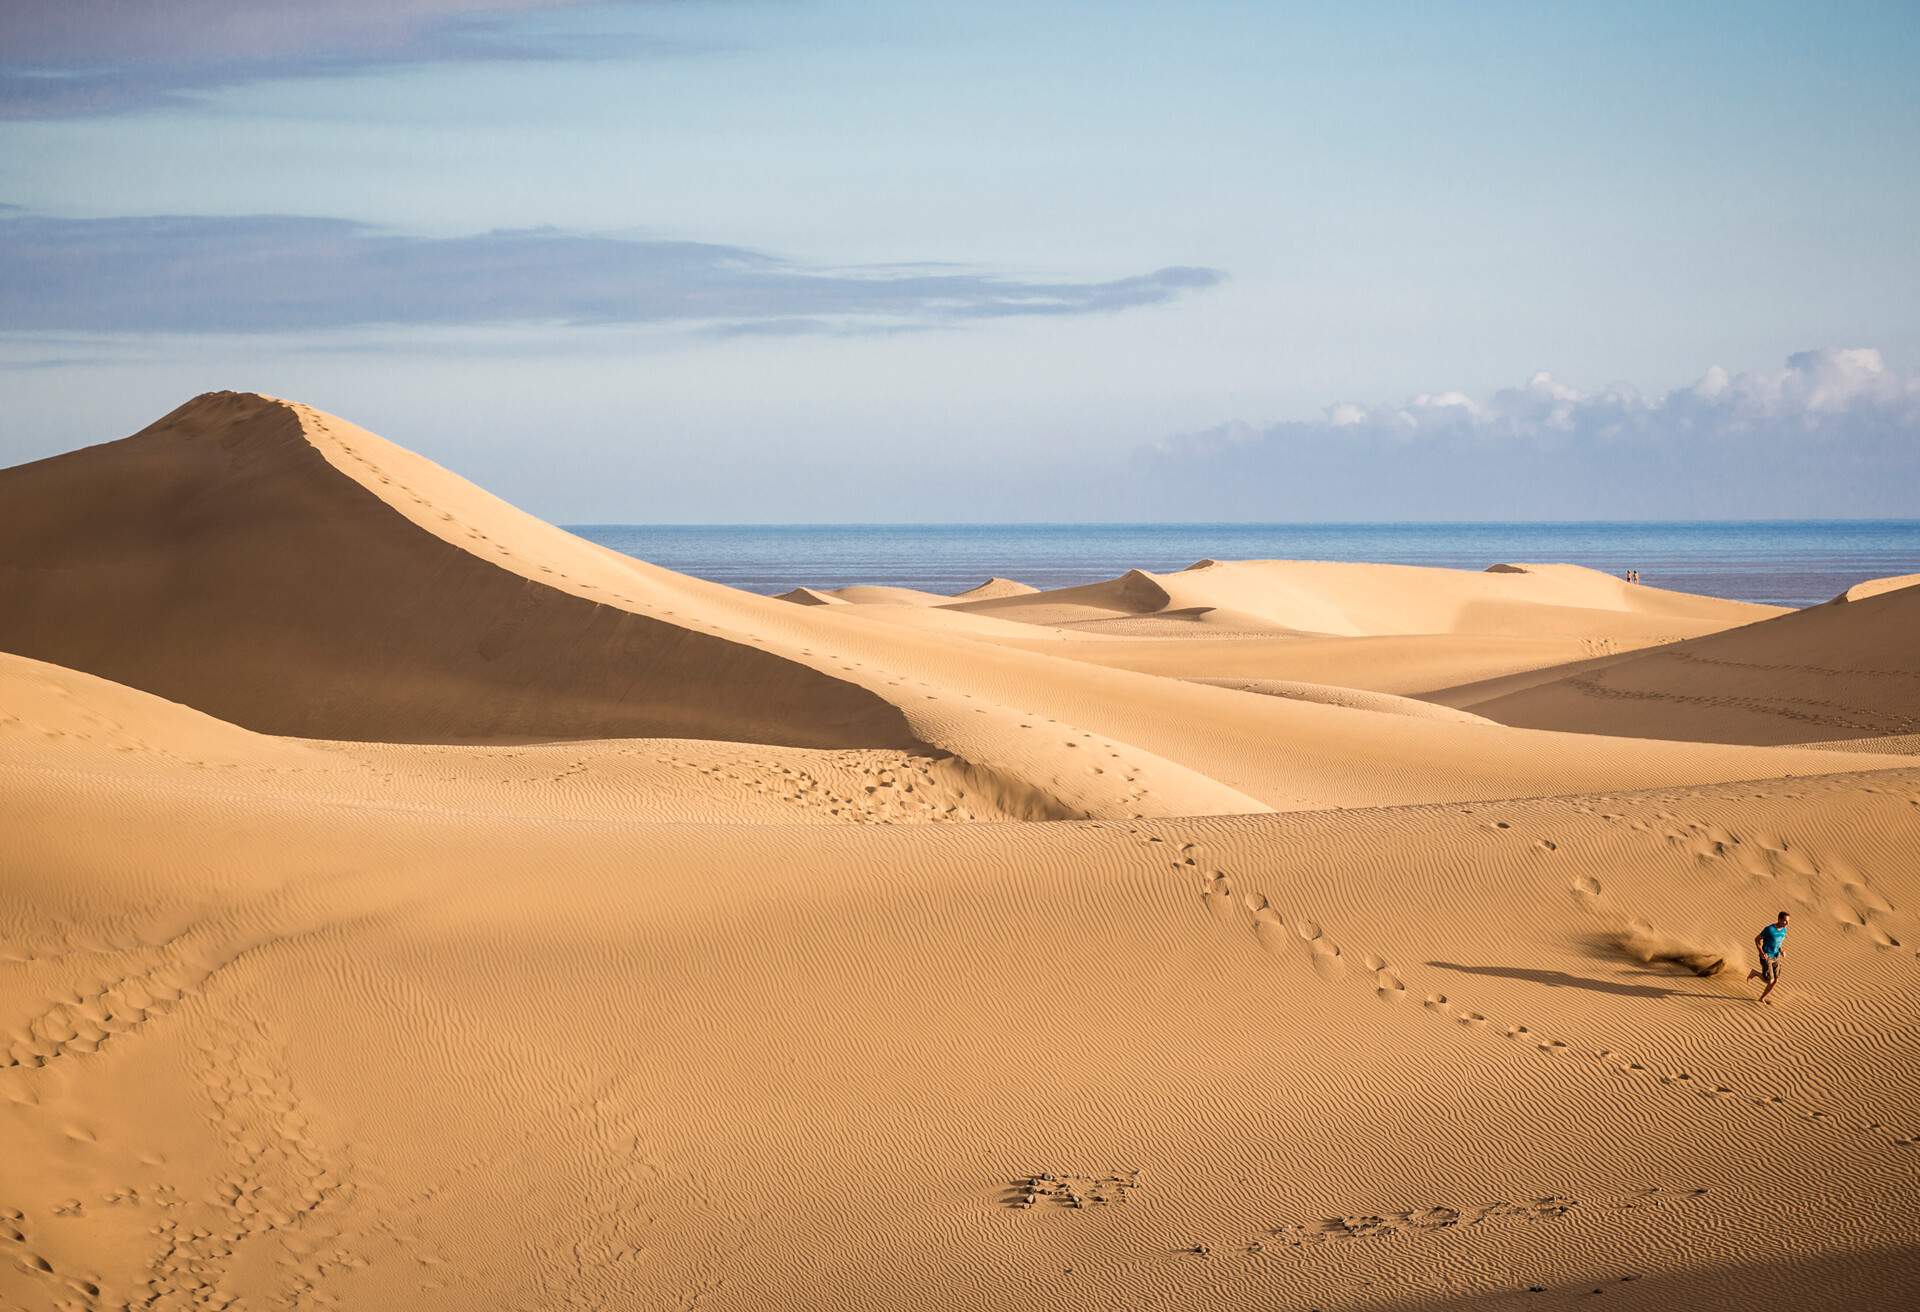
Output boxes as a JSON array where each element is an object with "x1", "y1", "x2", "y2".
[{"x1": 0, "y1": 0, "x2": 1920, "y2": 522}]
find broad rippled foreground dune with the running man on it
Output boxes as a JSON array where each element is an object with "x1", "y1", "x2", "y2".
[{"x1": 0, "y1": 649, "x2": 1920, "y2": 1310}]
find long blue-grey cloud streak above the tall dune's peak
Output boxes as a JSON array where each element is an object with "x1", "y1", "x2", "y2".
[{"x1": 0, "y1": 213, "x2": 1223, "y2": 334}]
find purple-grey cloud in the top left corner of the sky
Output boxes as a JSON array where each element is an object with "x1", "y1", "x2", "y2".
[{"x1": 0, "y1": 0, "x2": 678, "y2": 119}]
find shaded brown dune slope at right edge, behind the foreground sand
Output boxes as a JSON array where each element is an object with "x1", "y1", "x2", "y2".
[{"x1": 1434, "y1": 576, "x2": 1920, "y2": 743}]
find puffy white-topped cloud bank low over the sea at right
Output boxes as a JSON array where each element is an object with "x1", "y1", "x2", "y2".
[{"x1": 1137, "y1": 348, "x2": 1920, "y2": 521}]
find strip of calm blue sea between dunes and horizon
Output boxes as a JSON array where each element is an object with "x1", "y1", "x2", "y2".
[{"x1": 572, "y1": 519, "x2": 1920, "y2": 605}]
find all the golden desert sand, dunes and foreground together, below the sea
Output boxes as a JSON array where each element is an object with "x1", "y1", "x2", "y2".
[{"x1": 0, "y1": 394, "x2": 1920, "y2": 1310}]
